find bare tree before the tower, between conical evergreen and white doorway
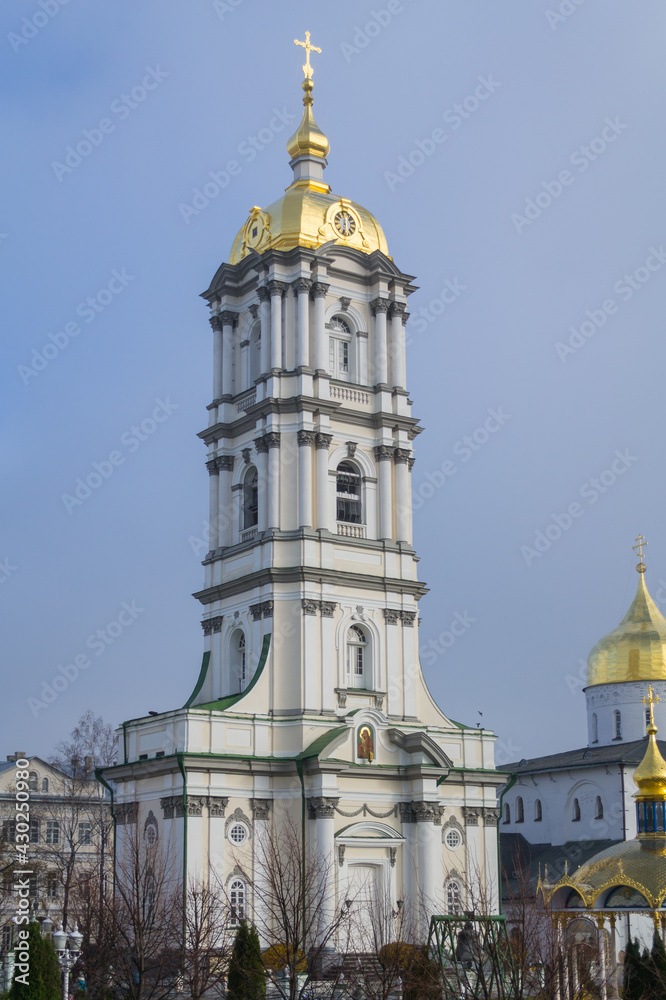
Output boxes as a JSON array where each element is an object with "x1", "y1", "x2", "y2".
[{"x1": 228, "y1": 817, "x2": 349, "y2": 1000}]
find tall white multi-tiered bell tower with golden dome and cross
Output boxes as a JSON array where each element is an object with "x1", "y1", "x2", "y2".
[{"x1": 104, "y1": 36, "x2": 505, "y2": 936}]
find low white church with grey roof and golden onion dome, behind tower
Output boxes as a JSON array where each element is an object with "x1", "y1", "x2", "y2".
[{"x1": 500, "y1": 536, "x2": 666, "y2": 873}]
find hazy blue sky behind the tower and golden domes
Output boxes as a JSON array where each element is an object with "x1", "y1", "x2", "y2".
[{"x1": 0, "y1": 0, "x2": 666, "y2": 761}]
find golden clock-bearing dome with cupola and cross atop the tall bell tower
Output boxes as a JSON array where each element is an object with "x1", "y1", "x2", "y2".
[{"x1": 229, "y1": 32, "x2": 389, "y2": 264}]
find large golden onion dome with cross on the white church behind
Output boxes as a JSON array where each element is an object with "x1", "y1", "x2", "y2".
[{"x1": 587, "y1": 562, "x2": 666, "y2": 687}]
